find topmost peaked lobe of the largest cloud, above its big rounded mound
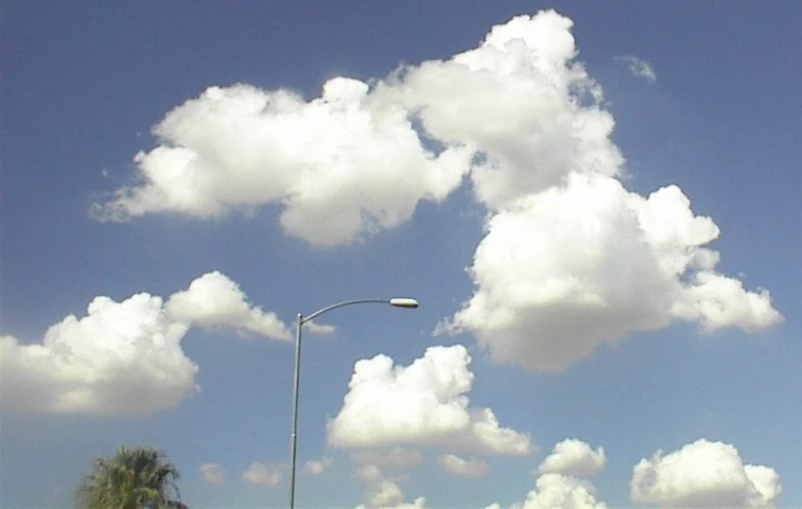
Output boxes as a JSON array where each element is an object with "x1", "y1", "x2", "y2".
[{"x1": 396, "y1": 11, "x2": 623, "y2": 209}]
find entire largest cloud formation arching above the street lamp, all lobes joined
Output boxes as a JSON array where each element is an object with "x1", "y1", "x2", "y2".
[{"x1": 93, "y1": 11, "x2": 782, "y2": 371}]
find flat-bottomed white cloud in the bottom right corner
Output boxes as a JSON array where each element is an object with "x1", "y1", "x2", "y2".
[{"x1": 630, "y1": 439, "x2": 782, "y2": 508}]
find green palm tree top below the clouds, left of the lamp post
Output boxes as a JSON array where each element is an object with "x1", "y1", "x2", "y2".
[{"x1": 76, "y1": 447, "x2": 187, "y2": 509}]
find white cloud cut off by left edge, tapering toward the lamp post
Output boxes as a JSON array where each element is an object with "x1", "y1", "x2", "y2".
[{"x1": 0, "y1": 272, "x2": 286, "y2": 415}]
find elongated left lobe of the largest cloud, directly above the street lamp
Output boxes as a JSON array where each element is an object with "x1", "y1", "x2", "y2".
[{"x1": 93, "y1": 78, "x2": 470, "y2": 245}]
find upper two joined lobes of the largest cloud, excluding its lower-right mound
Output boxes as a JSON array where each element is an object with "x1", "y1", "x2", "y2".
[{"x1": 92, "y1": 11, "x2": 623, "y2": 245}]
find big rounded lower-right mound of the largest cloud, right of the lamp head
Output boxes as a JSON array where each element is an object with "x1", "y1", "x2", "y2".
[{"x1": 440, "y1": 173, "x2": 782, "y2": 371}]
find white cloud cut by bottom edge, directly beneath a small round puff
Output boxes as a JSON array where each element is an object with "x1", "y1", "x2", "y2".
[{"x1": 486, "y1": 473, "x2": 607, "y2": 509}]
